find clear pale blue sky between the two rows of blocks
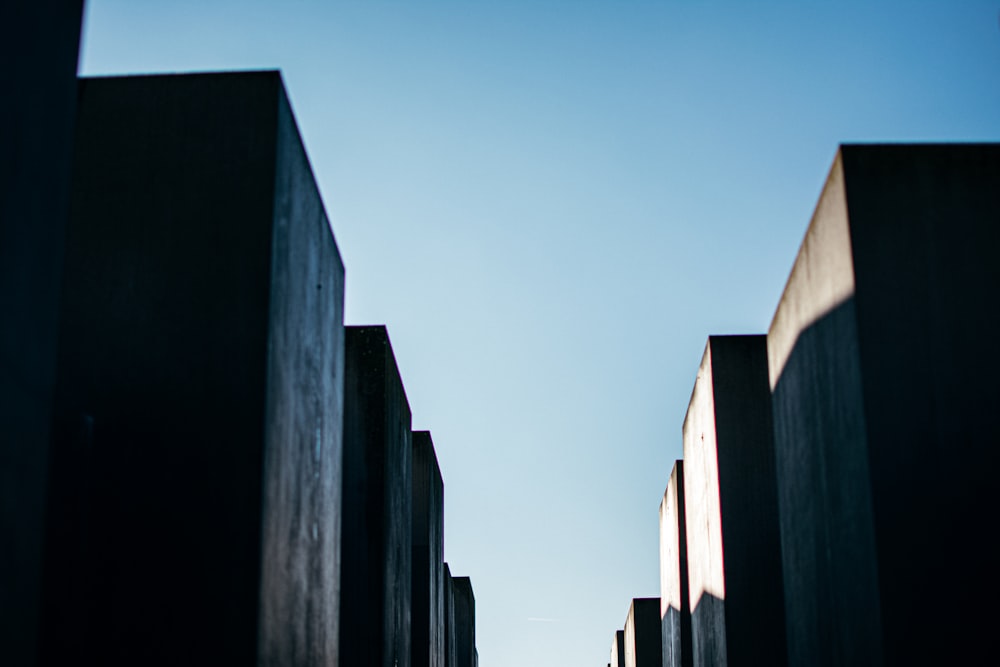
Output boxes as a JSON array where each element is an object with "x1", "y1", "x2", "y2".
[{"x1": 80, "y1": 0, "x2": 1000, "y2": 667}]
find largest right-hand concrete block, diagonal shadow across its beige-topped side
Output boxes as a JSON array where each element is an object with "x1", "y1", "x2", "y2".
[{"x1": 768, "y1": 144, "x2": 1000, "y2": 666}]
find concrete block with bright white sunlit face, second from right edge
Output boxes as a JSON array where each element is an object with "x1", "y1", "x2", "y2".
[{"x1": 683, "y1": 336, "x2": 786, "y2": 665}]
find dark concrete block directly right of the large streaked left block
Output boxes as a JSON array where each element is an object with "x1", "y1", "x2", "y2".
[{"x1": 340, "y1": 326, "x2": 413, "y2": 667}]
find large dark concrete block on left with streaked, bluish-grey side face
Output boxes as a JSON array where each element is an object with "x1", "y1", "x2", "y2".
[{"x1": 41, "y1": 72, "x2": 344, "y2": 665}]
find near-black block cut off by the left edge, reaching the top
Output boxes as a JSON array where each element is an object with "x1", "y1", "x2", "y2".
[{"x1": 0, "y1": 0, "x2": 83, "y2": 667}]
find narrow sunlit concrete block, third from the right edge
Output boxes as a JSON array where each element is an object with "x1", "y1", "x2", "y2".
[{"x1": 660, "y1": 461, "x2": 692, "y2": 667}]
